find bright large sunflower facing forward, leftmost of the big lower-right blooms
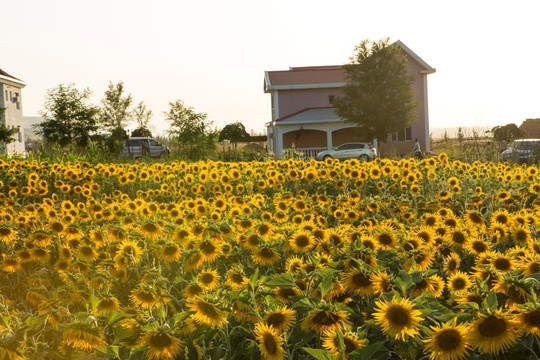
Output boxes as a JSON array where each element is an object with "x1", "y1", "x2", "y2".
[{"x1": 373, "y1": 297, "x2": 422, "y2": 341}]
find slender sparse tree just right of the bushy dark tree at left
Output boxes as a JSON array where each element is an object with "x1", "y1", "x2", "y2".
[{"x1": 99, "y1": 81, "x2": 133, "y2": 133}]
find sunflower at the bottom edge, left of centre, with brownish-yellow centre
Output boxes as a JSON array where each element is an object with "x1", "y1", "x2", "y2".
[{"x1": 138, "y1": 329, "x2": 182, "y2": 360}]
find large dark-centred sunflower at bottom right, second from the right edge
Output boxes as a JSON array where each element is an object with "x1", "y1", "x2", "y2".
[{"x1": 468, "y1": 309, "x2": 519, "y2": 355}]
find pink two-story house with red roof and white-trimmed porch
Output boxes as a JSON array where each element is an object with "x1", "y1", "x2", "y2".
[{"x1": 264, "y1": 40, "x2": 435, "y2": 159}]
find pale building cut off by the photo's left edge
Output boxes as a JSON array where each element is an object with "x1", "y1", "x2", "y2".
[{"x1": 0, "y1": 69, "x2": 26, "y2": 154}]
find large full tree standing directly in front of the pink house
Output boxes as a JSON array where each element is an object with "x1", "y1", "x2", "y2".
[{"x1": 332, "y1": 38, "x2": 418, "y2": 142}]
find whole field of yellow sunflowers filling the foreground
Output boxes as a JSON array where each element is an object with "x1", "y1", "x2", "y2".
[{"x1": 0, "y1": 153, "x2": 540, "y2": 360}]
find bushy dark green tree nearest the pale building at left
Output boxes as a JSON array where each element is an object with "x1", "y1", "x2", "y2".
[{"x1": 33, "y1": 84, "x2": 99, "y2": 147}]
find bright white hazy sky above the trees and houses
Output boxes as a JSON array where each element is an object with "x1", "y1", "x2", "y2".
[{"x1": 0, "y1": 0, "x2": 540, "y2": 136}]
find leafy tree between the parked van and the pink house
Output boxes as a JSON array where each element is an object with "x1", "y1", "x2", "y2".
[{"x1": 164, "y1": 100, "x2": 216, "y2": 160}]
